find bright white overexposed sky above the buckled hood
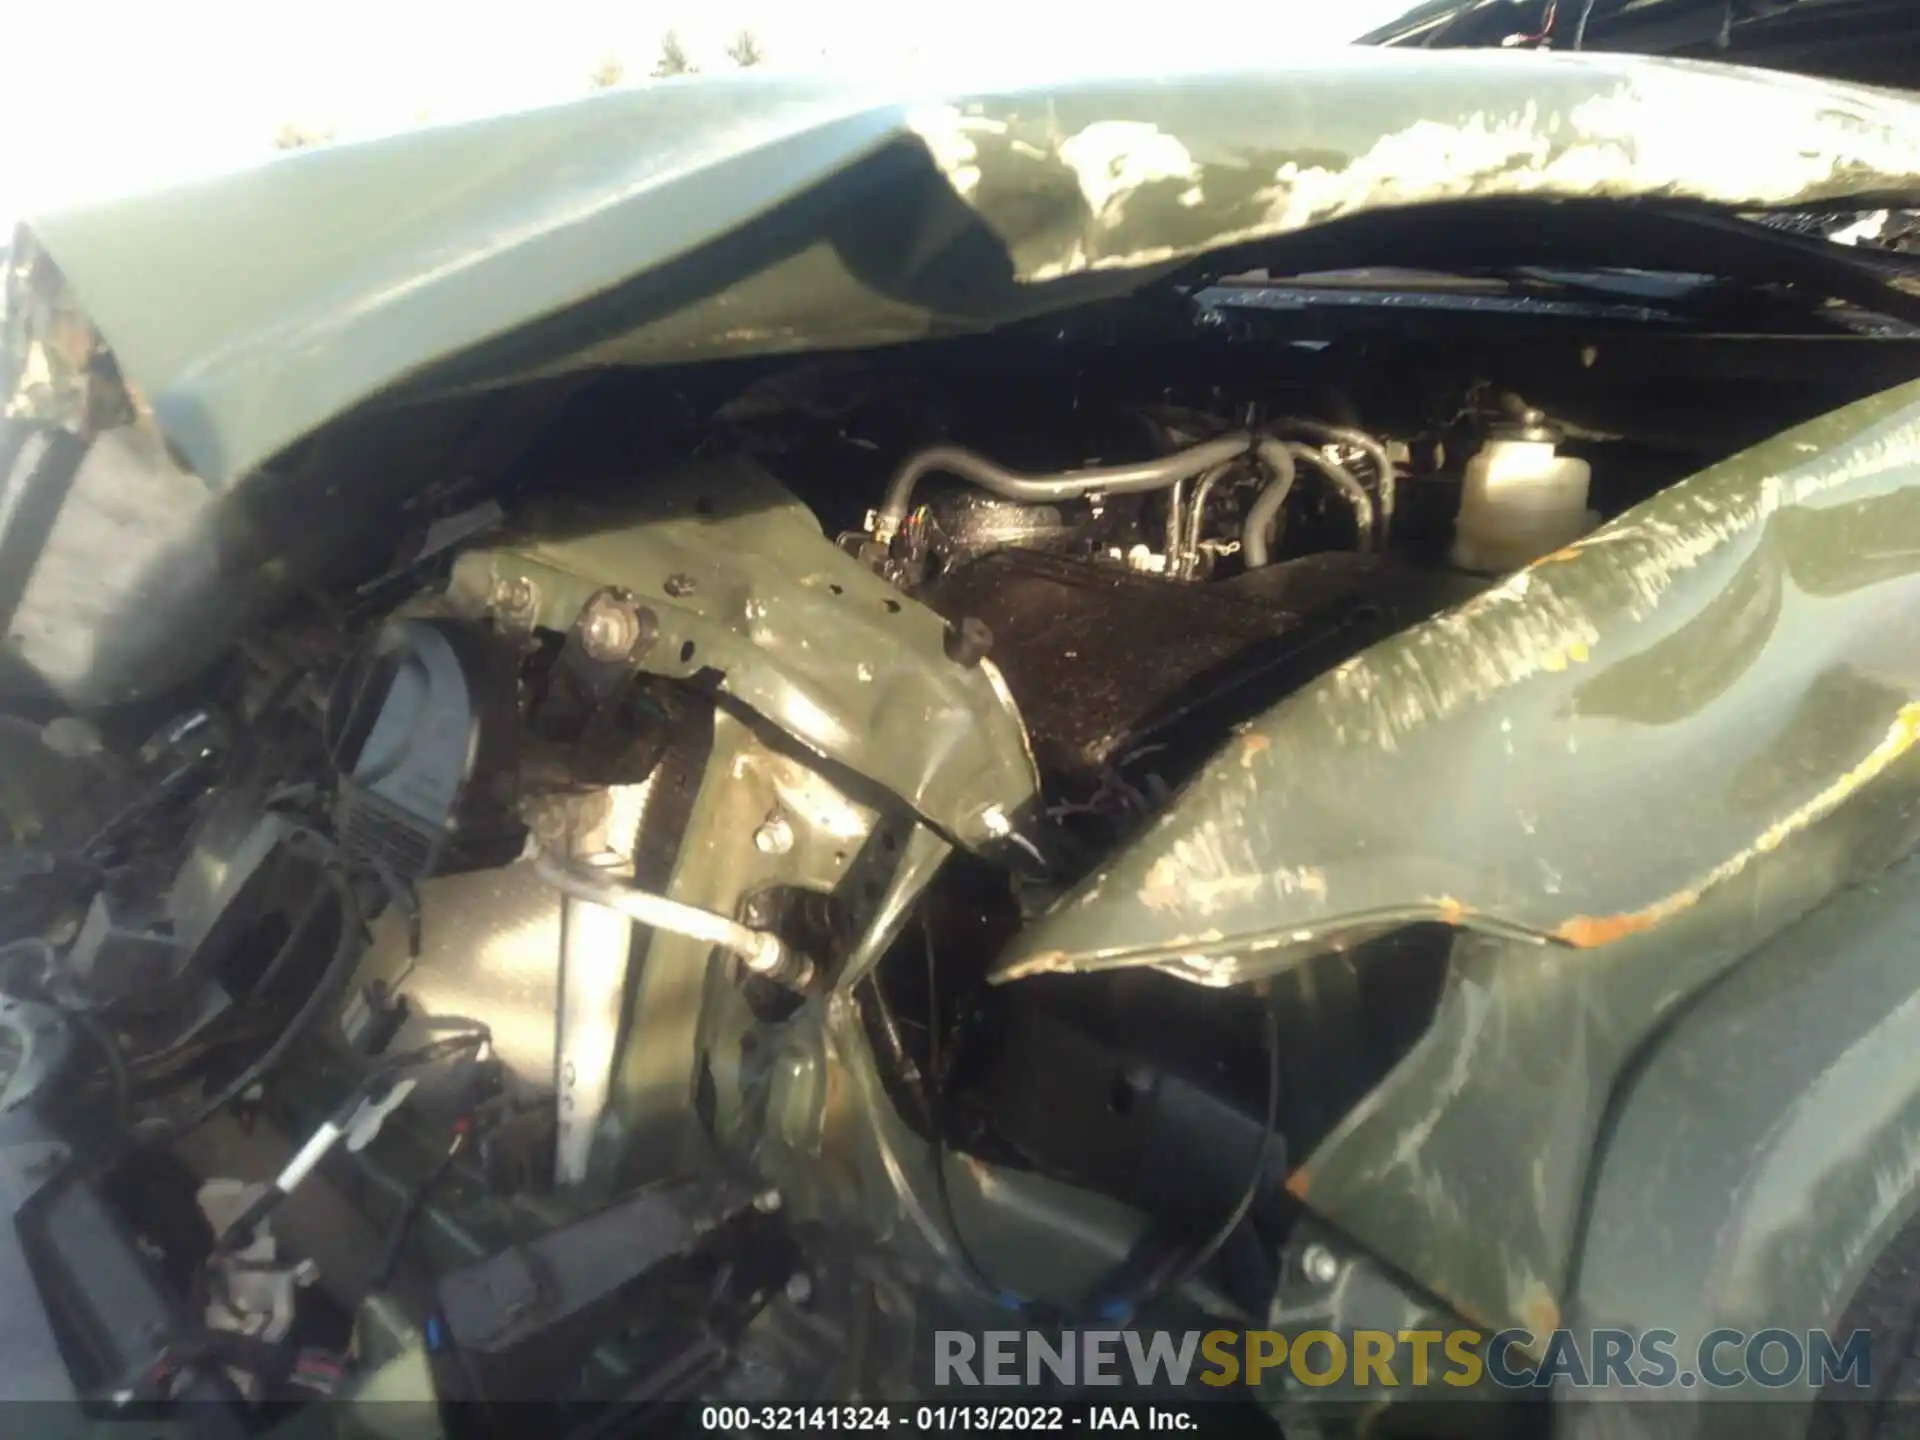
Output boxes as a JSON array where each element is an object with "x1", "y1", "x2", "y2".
[{"x1": 0, "y1": 0, "x2": 1411, "y2": 230}]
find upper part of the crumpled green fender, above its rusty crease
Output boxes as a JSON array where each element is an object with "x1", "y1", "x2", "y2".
[{"x1": 998, "y1": 384, "x2": 1920, "y2": 985}]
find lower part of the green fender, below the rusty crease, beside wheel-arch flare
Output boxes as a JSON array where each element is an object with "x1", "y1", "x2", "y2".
[{"x1": 1288, "y1": 768, "x2": 1920, "y2": 1334}]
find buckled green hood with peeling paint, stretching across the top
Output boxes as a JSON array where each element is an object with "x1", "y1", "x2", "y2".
[{"x1": 23, "y1": 50, "x2": 1920, "y2": 486}]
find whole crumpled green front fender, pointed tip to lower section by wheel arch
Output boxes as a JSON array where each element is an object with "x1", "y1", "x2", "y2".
[{"x1": 998, "y1": 374, "x2": 1920, "y2": 1331}]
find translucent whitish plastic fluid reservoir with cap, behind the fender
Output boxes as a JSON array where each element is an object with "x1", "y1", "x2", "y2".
[{"x1": 1452, "y1": 415, "x2": 1599, "y2": 572}]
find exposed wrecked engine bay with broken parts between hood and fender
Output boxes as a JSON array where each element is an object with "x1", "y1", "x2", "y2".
[{"x1": 0, "y1": 276, "x2": 1912, "y2": 1417}]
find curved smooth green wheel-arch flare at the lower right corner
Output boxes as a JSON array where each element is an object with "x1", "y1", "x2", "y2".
[{"x1": 1561, "y1": 862, "x2": 1920, "y2": 1440}]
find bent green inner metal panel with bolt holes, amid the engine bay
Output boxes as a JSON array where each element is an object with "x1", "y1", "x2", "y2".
[{"x1": 449, "y1": 457, "x2": 1039, "y2": 847}]
